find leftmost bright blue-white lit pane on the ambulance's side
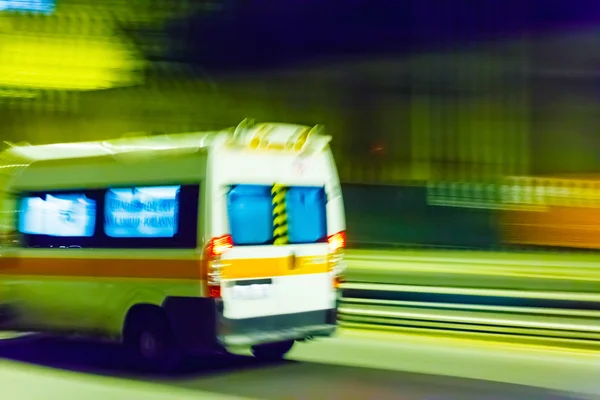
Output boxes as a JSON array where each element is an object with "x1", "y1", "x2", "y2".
[{"x1": 18, "y1": 191, "x2": 97, "y2": 247}]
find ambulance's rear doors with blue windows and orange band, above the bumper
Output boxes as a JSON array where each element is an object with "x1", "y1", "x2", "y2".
[{"x1": 222, "y1": 184, "x2": 335, "y2": 322}]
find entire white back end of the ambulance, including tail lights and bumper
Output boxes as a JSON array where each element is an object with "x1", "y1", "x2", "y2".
[{"x1": 205, "y1": 140, "x2": 345, "y2": 344}]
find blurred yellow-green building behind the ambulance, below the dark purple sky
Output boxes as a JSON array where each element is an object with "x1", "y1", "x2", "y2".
[{"x1": 0, "y1": 0, "x2": 600, "y2": 183}]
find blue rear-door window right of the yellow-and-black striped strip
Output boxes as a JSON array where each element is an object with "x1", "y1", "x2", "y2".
[{"x1": 286, "y1": 187, "x2": 327, "y2": 243}]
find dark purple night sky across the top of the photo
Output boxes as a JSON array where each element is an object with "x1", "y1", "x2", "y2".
[{"x1": 162, "y1": 0, "x2": 600, "y2": 72}]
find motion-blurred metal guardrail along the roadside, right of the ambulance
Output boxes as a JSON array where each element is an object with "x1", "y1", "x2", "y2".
[{"x1": 340, "y1": 251, "x2": 600, "y2": 341}]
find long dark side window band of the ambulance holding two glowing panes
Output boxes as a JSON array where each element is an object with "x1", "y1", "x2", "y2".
[{"x1": 17, "y1": 185, "x2": 200, "y2": 249}]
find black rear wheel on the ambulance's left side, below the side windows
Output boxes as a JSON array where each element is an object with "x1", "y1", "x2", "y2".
[{"x1": 124, "y1": 309, "x2": 181, "y2": 372}]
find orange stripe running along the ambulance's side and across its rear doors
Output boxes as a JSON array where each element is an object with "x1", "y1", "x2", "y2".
[{"x1": 0, "y1": 257, "x2": 327, "y2": 280}]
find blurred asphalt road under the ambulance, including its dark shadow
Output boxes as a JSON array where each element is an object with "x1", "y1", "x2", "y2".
[{"x1": 0, "y1": 330, "x2": 600, "y2": 400}]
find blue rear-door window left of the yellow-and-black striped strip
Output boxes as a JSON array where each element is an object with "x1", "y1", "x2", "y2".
[{"x1": 227, "y1": 185, "x2": 273, "y2": 245}]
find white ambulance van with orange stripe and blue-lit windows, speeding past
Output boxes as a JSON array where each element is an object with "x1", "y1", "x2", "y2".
[{"x1": 0, "y1": 120, "x2": 346, "y2": 369}]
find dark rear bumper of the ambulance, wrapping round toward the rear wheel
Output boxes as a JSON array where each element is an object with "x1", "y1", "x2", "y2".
[{"x1": 163, "y1": 297, "x2": 337, "y2": 351}]
